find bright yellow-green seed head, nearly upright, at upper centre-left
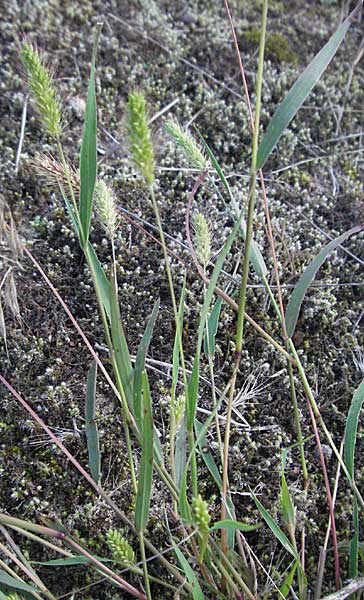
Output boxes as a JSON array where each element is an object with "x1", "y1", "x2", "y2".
[{"x1": 127, "y1": 91, "x2": 155, "y2": 185}]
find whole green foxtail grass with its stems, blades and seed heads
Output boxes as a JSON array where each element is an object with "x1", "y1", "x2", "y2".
[{"x1": 0, "y1": 0, "x2": 364, "y2": 600}]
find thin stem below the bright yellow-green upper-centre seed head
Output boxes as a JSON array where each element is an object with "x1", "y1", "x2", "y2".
[{"x1": 149, "y1": 185, "x2": 198, "y2": 496}]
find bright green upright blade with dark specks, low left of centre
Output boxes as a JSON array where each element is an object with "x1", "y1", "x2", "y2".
[{"x1": 135, "y1": 371, "x2": 153, "y2": 532}]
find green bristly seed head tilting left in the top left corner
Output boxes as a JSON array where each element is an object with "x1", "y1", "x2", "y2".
[{"x1": 20, "y1": 41, "x2": 62, "y2": 137}]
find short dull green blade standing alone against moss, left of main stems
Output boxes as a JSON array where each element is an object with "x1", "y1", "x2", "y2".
[{"x1": 85, "y1": 361, "x2": 101, "y2": 485}]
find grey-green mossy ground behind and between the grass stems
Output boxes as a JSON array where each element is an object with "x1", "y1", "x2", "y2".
[{"x1": 0, "y1": 1, "x2": 364, "y2": 598}]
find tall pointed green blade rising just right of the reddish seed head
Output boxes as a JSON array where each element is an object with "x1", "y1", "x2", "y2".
[{"x1": 79, "y1": 26, "x2": 101, "y2": 248}]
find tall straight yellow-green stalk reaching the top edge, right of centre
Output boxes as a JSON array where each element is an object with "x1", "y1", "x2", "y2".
[{"x1": 221, "y1": 0, "x2": 268, "y2": 552}]
